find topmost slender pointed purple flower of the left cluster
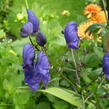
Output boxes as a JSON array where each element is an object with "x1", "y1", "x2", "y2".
[{"x1": 27, "y1": 9, "x2": 39, "y2": 33}]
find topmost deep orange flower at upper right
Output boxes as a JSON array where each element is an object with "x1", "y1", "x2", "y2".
[{"x1": 84, "y1": 4, "x2": 101, "y2": 15}]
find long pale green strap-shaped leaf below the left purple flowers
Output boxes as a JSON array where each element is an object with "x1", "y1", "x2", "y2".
[{"x1": 40, "y1": 87, "x2": 82, "y2": 106}]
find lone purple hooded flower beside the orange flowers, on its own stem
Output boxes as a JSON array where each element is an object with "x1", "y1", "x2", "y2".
[{"x1": 63, "y1": 21, "x2": 80, "y2": 49}]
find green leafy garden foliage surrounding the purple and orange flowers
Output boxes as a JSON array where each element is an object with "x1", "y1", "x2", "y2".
[{"x1": 0, "y1": 0, "x2": 109, "y2": 109}]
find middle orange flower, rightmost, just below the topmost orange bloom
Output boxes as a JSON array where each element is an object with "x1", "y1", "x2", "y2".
[{"x1": 90, "y1": 11, "x2": 106, "y2": 23}]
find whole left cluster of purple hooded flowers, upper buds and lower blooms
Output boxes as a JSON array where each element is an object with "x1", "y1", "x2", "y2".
[{"x1": 20, "y1": 10, "x2": 50, "y2": 91}]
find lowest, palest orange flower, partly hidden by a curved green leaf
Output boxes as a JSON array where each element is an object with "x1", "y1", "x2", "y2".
[{"x1": 78, "y1": 21, "x2": 95, "y2": 39}]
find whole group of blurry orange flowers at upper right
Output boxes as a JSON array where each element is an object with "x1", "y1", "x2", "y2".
[{"x1": 78, "y1": 4, "x2": 106, "y2": 39}]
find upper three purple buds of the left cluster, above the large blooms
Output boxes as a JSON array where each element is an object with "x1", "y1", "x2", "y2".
[{"x1": 20, "y1": 9, "x2": 47, "y2": 46}]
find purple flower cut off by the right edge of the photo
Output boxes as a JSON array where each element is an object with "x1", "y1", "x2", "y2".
[{"x1": 102, "y1": 52, "x2": 109, "y2": 79}]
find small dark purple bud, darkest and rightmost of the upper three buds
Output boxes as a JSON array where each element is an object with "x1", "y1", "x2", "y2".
[{"x1": 36, "y1": 32, "x2": 47, "y2": 46}]
